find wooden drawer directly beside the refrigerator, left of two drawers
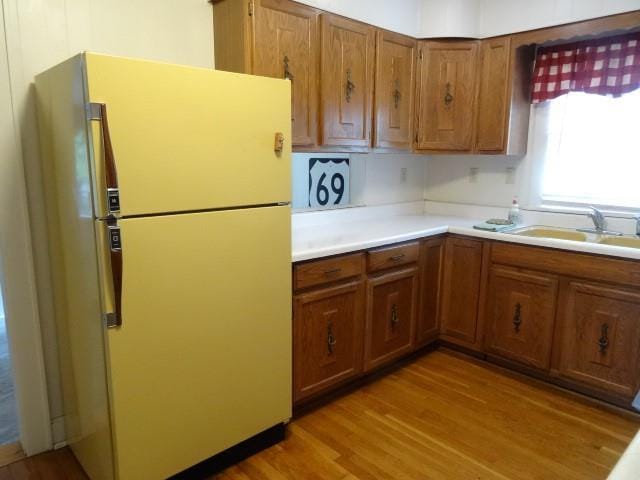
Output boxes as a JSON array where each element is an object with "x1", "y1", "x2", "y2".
[{"x1": 293, "y1": 253, "x2": 364, "y2": 290}]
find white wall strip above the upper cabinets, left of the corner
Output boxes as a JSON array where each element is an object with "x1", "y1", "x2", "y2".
[{"x1": 298, "y1": 0, "x2": 422, "y2": 36}]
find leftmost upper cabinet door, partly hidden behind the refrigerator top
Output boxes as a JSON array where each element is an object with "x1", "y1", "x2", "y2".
[{"x1": 253, "y1": 0, "x2": 319, "y2": 146}]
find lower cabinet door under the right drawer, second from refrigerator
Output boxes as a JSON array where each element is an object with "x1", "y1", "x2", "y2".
[{"x1": 365, "y1": 268, "x2": 418, "y2": 371}]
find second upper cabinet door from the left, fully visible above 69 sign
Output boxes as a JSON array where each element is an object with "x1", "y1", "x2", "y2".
[{"x1": 321, "y1": 14, "x2": 375, "y2": 147}]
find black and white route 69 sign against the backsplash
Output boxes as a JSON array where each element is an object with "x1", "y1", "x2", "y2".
[{"x1": 309, "y1": 158, "x2": 349, "y2": 207}]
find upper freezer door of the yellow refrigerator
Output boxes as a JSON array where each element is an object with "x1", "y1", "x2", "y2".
[{"x1": 84, "y1": 53, "x2": 291, "y2": 217}]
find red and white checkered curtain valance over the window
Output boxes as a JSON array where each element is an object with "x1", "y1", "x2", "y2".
[{"x1": 531, "y1": 32, "x2": 640, "y2": 103}]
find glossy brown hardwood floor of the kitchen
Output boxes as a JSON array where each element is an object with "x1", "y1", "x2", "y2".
[{"x1": 6, "y1": 350, "x2": 640, "y2": 480}]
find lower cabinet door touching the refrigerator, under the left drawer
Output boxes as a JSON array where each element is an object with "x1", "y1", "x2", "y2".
[{"x1": 293, "y1": 282, "x2": 364, "y2": 402}]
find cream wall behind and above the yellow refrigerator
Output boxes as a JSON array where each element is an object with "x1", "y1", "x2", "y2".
[{"x1": 0, "y1": 0, "x2": 213, "y2": 442}]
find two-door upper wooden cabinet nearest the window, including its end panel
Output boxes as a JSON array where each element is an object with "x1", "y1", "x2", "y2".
[{"x1": 415, "y1": 36, "x2": 533, "y2": 155}]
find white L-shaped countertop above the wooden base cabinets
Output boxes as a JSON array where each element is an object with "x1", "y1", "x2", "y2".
[{"x1": 292, "y1": 214, "x2": 640, "y2": 262}]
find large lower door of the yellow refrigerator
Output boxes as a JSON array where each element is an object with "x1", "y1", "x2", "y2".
[{"x1": 101, "y1": 206, "x2": 291, "y2": 480}]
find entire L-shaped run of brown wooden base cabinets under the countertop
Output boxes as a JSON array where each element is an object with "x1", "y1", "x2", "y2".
[{"x1": 293, "y1": 235, "x2": 640, "y2": 408}]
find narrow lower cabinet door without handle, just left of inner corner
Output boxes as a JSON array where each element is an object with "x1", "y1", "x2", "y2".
[{"x1": 416, "y1": 237, "x2": 445, "y2": 346}]
